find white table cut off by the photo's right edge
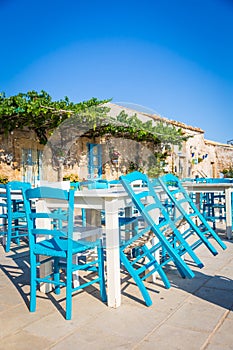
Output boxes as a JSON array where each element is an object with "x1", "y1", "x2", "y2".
[{"x1": 182, "y1": 182, "x2": 233, "y2": 239}]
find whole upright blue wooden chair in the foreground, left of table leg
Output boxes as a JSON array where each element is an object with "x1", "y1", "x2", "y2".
[{"x1": 24, "y1": 187, "x2": 106, "y2": 320}]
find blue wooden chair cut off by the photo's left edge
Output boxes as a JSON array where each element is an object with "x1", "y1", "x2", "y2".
[{"x1": 0, "y1": 181, "x2": 31, "y2": 252}]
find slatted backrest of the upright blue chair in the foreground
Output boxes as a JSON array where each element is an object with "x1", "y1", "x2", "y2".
[{"x1": 24, "y1": 187, "x2": 74, "y2": 249}]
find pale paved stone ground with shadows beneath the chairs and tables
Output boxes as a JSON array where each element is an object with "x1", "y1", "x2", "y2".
[{"x1": 0, "y1": 227, "x2": 233, "y2": 350}]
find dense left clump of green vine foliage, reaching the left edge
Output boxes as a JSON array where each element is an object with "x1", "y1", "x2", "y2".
[{"x1": 0, "y1": 90, "x2": 107, "y2": 144}]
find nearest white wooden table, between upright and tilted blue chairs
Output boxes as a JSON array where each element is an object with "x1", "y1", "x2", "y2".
[{"x1": 75, "y1": 188, "x2": 132, "y2": 308}]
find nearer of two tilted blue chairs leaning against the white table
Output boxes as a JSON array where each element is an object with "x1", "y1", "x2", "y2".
[{"x1": 120, "y1": 172, "x2": 203, "y2": 306}]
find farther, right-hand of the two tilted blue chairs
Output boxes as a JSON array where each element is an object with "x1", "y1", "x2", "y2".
[{"x1": 158, "y1": 174, "x2": 226, "y2": 255}]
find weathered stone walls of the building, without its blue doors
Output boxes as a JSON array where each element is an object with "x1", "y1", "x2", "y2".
[{"x1": 0, "y1": 106, "x2": 233, "y2": 181}]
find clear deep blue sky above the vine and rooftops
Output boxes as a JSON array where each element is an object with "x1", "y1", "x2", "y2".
[{"x1": 0, "y1": 0, "x2": 233, "y2": 142}]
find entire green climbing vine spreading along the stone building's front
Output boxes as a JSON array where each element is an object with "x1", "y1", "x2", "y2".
[{"x1": 0, "y1": 90, "x2": 187, "y2": 178}]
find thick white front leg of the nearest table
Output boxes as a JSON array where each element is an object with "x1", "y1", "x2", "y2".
[{"x1": 105, "y1": 199, "x2": 121, "y2": 308}]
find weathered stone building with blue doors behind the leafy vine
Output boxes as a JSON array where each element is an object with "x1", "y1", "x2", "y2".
[{"x1": 0, "y1": 103, "x2": 233, "y2": 184}]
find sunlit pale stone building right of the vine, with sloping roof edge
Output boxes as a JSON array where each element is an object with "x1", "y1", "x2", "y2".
[{"x1": 108, "y1": 103, "x2": 233, "y2": 178}]
